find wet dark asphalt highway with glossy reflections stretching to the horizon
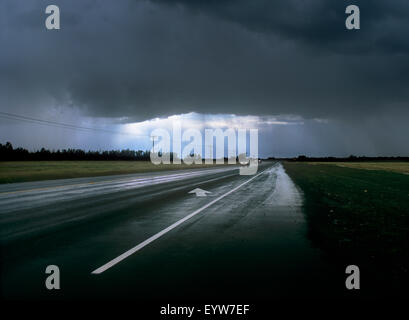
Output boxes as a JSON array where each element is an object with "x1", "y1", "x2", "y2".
[{"x1": 0, "y1": 162, "x2": 344, "y2": 302}]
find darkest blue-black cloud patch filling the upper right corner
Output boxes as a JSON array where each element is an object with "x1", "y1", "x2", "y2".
[{"x1": 154, "y1": 0, "x2": 409, "y2": 53}]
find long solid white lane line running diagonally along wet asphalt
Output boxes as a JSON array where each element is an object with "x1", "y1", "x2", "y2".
[{"x1": 91, "y1": 171, "x2": 264, "y2": 274}]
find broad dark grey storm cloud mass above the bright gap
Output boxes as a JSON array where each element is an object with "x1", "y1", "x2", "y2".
[{"x1": 0, "y1": 0, "x2": 409, "y2": 120}]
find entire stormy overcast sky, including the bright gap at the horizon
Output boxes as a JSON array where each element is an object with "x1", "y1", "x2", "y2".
[{"x1": 0, "y1": 0, "x2": 409, "y2": 156}]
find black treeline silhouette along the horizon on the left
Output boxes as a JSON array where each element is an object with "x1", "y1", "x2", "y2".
[{"x1": 0, "y1": 142, "x2": 150, "y2": 161}]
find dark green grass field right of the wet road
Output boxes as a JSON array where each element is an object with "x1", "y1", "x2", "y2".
[{"x1": 284, "y1": 162, "x2": 409, "y2": 289}]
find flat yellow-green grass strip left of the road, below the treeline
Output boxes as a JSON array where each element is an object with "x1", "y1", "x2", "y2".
[{"x1": 0, "y1": 161, "x2": 223, "y2": 183}]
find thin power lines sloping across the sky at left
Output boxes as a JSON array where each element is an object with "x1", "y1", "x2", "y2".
[{"x1": 0, "y1": 111, "x2": 150, "y2": 137}]
